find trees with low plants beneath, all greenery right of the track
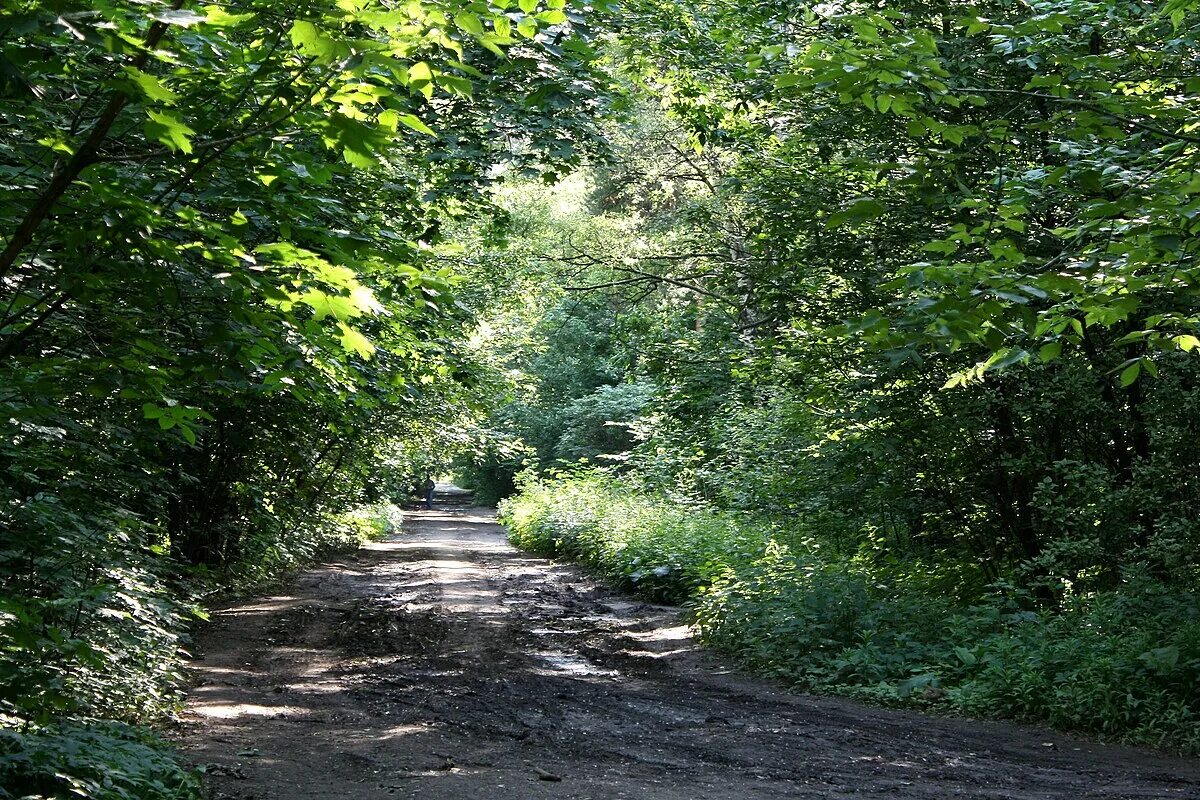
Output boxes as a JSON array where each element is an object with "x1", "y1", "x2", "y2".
[{"x1": 460, "y1": 1, "x2": 1200, "y2": 751}]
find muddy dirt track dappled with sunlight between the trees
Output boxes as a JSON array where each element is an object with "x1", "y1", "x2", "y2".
[{"x1": 181, "y1": 492, "x2": 1200, "y2": 800}]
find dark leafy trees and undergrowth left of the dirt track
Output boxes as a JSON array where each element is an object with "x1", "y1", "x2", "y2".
[{"x1": 0, "y1": 0, "x2": 614, "y2": 799}]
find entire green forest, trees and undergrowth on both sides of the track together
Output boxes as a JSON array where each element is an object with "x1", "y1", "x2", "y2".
[{"x1": 0, "y1": 0, "x2": 1200, "y2": 799}]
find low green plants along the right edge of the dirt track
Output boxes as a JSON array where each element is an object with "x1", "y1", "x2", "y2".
[{"x1": 502, "y1": 476, "x2": 1200, "y2": 753}]
